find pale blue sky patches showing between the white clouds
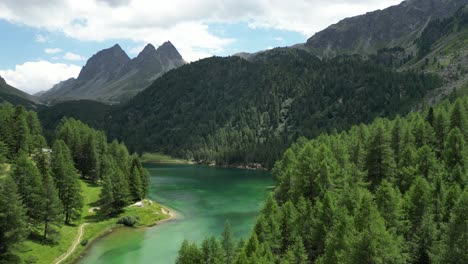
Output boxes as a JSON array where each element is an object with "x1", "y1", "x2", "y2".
[{"x1": 0, "y1": 20, "x2": 307, "y2": 69}]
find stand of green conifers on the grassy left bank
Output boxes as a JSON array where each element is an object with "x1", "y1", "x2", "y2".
[{"x1": 0, "y1": 104, "x2": 149, "y2": 262}]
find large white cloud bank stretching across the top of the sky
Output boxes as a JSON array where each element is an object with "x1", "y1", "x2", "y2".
[{"x1": 0, "y1": 0, "x2": 401, "y2": 61}]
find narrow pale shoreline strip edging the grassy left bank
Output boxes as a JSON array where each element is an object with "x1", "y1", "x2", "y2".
[{"x1": 69, "y1": 201, "x2": 178, "y2": 264}]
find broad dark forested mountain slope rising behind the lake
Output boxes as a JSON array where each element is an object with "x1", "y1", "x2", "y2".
[{"x1": 107, "y1": 49, "x2": 440, "y2": 166}]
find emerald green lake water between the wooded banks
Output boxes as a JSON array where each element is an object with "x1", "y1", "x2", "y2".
[{"x1": 78, "y1": 164, "x2": 273, "y2": 264}]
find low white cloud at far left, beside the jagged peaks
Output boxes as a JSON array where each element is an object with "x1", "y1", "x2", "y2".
[{"x1": 0, "y1": 60, "x2": 81, "y2": 94}]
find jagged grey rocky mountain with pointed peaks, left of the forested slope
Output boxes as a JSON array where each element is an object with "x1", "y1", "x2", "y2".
[{"x1": 40, "y1": 42, "x2": 185, "y2": 104}]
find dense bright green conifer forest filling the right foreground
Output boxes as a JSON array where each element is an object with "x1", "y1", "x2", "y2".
[{"x1": 177, "y1": 97, "x2": 468, "y2": 264}]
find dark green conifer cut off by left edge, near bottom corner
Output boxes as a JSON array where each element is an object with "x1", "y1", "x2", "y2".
[{"x1": 0, "y1": 176, "x2": 28, "y2": 256}]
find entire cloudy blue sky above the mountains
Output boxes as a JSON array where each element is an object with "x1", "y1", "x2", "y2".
[{"x1": 0, "y1": 0, "x2": 402, "y2": 94}]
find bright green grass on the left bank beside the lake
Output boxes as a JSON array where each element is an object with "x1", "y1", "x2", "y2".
[{"x1": 15, "y1": 178, "x2": 168, "y2": 264}]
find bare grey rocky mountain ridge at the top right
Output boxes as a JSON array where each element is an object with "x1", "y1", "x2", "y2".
[{"x1": 305, "y1": 0, "x2": 468, "y2": 57}]
